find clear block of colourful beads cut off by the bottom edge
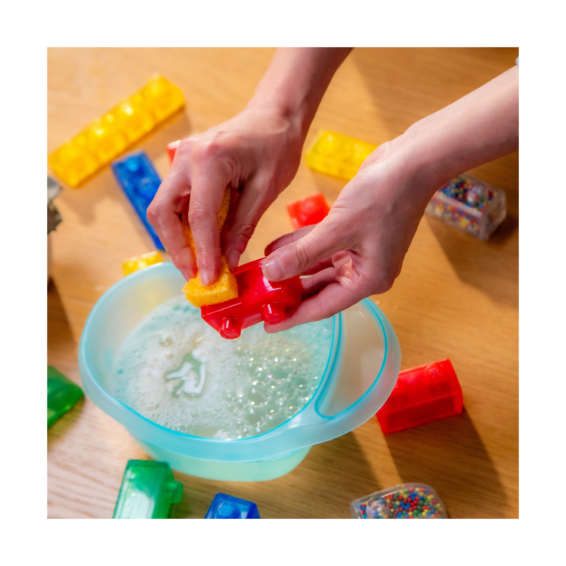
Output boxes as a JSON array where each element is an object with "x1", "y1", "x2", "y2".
[{"x1": 350, "y1": 483, "x2": 448, "y2": 521}]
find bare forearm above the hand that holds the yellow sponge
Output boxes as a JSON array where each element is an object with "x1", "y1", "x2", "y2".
[{"x1": 248, "y1": 46, "x2": 352, "y2": 138}]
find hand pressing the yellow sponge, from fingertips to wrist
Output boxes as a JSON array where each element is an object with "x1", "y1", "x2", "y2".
[{"x1": 147, "y1": 104, "x2": 303, "y2": 285}]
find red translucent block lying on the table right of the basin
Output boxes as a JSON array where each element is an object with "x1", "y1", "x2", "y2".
[{"x1": 377, "y1": 360, "x2": 464, "y2": 434}]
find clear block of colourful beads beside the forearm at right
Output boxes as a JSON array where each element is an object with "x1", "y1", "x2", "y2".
[{"x1": 426, "y1": 174, "x2": 507, "y2": 240}]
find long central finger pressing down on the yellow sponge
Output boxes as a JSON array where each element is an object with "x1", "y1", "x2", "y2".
[{"x1": 189, "y1": 157, "x2": 230, "y2": 286}]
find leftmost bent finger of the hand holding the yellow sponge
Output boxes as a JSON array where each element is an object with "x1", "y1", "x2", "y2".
[{"x1": 147, "y1": 172, "x2": 196, "y2": 280}]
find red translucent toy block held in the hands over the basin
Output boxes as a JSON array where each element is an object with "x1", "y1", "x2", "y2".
[{"x1": 200, "y1": 258, "x2": 303, "y2": 339}]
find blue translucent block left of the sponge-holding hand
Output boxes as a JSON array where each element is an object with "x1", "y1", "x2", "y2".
[{"x1": 112, "y1": 151, "x2": 165, "y2": 250}]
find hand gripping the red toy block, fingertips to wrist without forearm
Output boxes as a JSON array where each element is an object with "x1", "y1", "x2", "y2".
[{"x1": 264, "y1": 138, "x2": 438, "y2": 332}]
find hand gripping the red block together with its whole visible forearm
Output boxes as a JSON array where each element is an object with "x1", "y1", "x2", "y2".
[{"x1": 263, "y1": 67, "x2": 521, "y2": 332}]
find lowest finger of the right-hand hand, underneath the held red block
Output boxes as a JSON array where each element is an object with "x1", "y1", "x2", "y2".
[{"x1": 264, "y1": 281, "x2": 364, "y2": 334}]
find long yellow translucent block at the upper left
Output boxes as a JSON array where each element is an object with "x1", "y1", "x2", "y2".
[{"x1": 49, "y1": 75, "x2": 185, "y2": 188}]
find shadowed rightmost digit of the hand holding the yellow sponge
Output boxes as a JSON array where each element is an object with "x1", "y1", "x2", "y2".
[{"x1": 222, "y1": 178, "x2": 280, "y2": 271}]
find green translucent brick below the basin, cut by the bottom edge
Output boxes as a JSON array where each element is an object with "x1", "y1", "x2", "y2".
[{"x1": 112, "y1": 460, "x2": 183, "y2": 521}]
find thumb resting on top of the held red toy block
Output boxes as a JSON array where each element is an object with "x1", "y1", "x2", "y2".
[{"x1": 263, "y1": 222, "x2": 349, "y2": 281}]
